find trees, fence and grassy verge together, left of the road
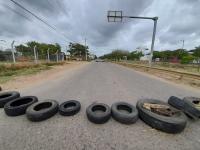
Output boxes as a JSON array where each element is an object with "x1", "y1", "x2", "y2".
[{"x1": 0, "y1": 41, "x2": 92, "y2": 83}]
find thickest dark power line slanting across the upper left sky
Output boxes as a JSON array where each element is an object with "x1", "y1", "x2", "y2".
[{"x1": 10, "y1": 0, "x2": 74, "y2": 42}]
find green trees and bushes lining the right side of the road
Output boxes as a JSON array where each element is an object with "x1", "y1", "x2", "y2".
[{"x1": 100, "y1": 46, "x2": 200, "y2": 73}]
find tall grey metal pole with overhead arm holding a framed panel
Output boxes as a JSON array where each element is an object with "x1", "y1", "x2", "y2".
[{"x1": 107, "y1": 11, "x2": 158, "y2": 66}]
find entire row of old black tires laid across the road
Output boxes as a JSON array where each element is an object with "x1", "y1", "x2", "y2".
[{"x1": 0, "y1": 92, "x2": 200, "y2": 133}]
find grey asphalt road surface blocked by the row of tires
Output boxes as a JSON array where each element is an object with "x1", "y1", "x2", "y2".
[{"x1": 0, "y1": 62, "x2": 200, "y2": 150}]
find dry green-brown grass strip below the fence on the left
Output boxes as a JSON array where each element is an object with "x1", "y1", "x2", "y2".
[{"x1": 0, "y1": 62, "x2": 64, "y2": 83}]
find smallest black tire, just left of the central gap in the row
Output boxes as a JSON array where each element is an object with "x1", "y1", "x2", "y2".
[{"x1": 59, "y1": 100, "x2": 81, "y2": 116}]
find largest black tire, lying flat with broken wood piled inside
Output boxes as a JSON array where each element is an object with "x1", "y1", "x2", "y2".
[{"x1": 137, "y1": 99, "x2": 186, "y2": 133}]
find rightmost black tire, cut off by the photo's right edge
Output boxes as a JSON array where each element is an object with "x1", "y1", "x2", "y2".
[{"x1": 183, "y1": 97, "x2": 200, "y2": 119}]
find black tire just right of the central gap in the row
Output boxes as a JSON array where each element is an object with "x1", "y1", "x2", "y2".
[{"x1": 86, "y1": 103, "x2": 111, "y2": 124}]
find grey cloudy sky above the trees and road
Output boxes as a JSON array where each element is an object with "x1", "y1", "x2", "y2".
[{"x1": 0, "y1": 0, "x2": 200, "y2": 56}]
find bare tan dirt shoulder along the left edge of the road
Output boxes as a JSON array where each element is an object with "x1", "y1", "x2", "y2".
[{"x1": 0, "y1": 61, "x2": 87, "y2": 90}]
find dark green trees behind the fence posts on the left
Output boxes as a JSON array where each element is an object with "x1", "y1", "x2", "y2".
[{"x1": 0, "y1": 41, "x2": 90, "y2": 61}]
